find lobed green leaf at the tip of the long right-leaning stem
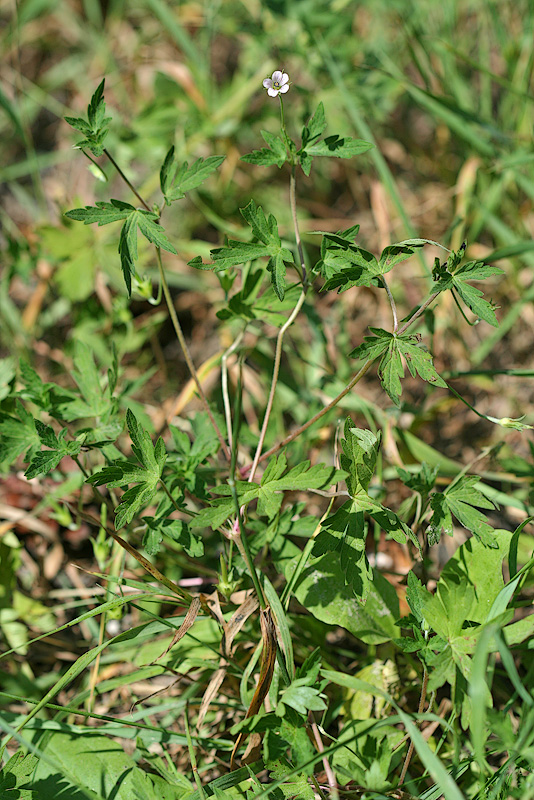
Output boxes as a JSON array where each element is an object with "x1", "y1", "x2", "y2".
[{"x1": 432, "y1": 255, "x2": 503, "y2": 328}]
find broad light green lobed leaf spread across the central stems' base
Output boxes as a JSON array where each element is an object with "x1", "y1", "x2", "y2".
[{"x1": 190, "y1": 453, "x2": 346, "y2": 530}]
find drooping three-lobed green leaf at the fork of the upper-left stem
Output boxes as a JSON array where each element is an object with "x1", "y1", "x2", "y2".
[{"x1": 65, "y1": 200, "x2": 177, "y2": 295}]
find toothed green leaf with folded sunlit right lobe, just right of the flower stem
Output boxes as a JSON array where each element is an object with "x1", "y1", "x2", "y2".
[{"x1": 320, "y1": 234, "x2": 441, "y2": 292}]
